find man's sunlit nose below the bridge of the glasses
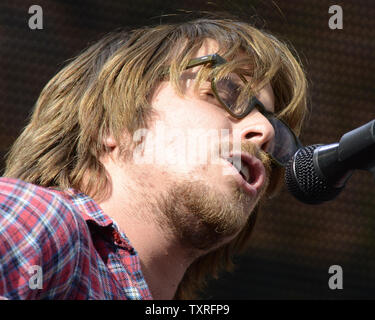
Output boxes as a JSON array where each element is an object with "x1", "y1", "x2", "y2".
[{"x1": 240, "y1": 109, "x2": 275, "y2": 152}]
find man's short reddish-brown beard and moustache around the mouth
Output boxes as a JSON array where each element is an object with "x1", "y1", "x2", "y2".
[{"x1": 157, "y1": 144, "x2": 270, "y2": 252}]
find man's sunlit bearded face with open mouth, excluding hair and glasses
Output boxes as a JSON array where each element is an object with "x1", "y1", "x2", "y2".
[{"x1": 128, "y1": 40, "x2": 274, "y2": 250}]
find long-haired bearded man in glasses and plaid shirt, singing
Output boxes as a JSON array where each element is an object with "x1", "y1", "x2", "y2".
[{"x1": 0, "y1": 18, "x2": 306, "y2": 299}]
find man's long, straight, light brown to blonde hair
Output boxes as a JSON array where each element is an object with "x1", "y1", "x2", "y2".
[{"x1": 5, "y1": 18, "x2": 307, "y2": 299}]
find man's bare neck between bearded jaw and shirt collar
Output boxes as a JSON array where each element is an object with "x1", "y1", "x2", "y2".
[{"x1": 99, "y1": 178, "x2": 198, "y2": 300}]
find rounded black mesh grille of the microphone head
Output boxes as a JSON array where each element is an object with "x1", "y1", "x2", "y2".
[{"x1": 285, "y1": 144, "x2": 342, "y2": 204}]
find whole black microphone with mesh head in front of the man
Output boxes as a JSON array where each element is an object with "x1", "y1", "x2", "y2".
[{"x1": 285, "y1": 120, "x2": 375, "y2": 204}]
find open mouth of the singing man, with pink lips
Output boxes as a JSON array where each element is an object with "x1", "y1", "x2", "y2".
[{"x1": 225, "y1": 152, "x2": 265, "y2": 196}]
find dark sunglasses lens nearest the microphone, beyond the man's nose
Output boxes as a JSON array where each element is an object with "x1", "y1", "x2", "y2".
[{"x1": 267, "y1": 117, "x2": 300, "y2": 165}]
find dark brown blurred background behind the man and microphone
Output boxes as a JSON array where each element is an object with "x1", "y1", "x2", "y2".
[{"x1": 0, "y1": 0, "x2": 375, "y2": 299}]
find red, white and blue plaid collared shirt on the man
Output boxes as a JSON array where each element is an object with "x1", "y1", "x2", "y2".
[{"x1": 0, "y1": 178, "x2": 152, "y2": 299}]
